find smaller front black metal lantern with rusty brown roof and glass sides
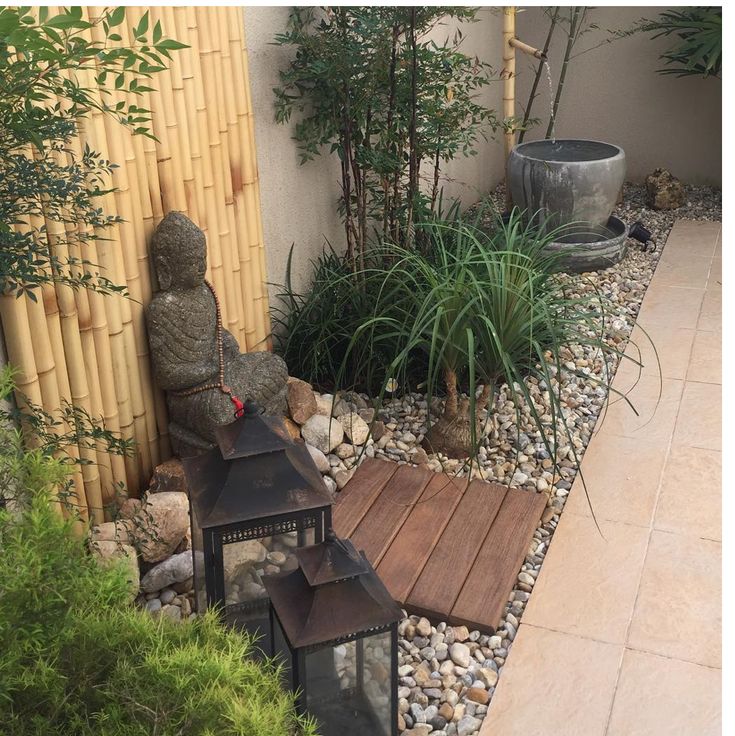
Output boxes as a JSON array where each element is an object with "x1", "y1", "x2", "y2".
[{"x1": 265, "y1": 530, "x2": 401, "y2": 736}]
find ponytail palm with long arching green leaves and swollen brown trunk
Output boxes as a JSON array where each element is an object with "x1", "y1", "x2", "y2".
[{"x1": 338, "y1": 211, "x2": 627, "y2": 458}]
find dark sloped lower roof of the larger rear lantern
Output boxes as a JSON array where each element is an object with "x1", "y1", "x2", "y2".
[{"x1": 181, "y1": 432, "x2": 332, "y2": 529}]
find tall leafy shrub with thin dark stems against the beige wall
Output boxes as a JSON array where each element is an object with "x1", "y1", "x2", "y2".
[{"x1": 274, "y1": 6, "x2": 499, "y2": 258}]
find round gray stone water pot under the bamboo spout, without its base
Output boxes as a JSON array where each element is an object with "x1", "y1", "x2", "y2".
[{"x1": 508, "y1": 139, "x2": 625, "y2": 227}]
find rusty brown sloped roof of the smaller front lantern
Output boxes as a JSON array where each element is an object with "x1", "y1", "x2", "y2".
[{"x1": 263, "y1": 540, "x2": 401, "y2": 649}]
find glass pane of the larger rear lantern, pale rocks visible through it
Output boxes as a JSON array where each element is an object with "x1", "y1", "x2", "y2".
[{"x1": 222, "y1": 527, "x2": 315, "y2": 651}]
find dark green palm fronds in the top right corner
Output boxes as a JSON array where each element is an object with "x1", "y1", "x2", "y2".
[{"x1": 641, "y1": 6, "x2": 722, "y2": 77}]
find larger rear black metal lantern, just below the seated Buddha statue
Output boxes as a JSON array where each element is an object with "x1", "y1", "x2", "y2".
[{"x1": 182, "y1": 405, "x2": 332, "y2": 651}]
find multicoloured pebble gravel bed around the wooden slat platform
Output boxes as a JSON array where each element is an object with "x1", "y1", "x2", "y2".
[{"x1": 340, "y1": 184, "x2": 722, "y2": 736}]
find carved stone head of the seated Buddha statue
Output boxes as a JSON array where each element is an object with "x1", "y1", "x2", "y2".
[{"x1": 151, "y1": 212, "x2": 207, "y2": 291}]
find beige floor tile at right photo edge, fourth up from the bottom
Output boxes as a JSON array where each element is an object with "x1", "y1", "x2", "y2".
[{"x1": 674, "y1": 381, "x2": 722, "y2": 450}]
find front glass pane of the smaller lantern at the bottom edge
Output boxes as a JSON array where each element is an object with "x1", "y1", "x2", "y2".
[{"x1": 304, "y1": 633, "x2": 391, "y2": 736}]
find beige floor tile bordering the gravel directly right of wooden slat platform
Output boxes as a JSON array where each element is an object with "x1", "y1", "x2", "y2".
[{"x1": 523, "y1": 511, "x2": 649, "y2": 644}]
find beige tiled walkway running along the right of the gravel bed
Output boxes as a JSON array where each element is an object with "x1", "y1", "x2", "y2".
[{"x1": 480, "y1": 220, "x2": 722, "y2": 736}]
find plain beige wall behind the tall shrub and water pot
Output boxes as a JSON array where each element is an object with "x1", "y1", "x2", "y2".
[{"x1": 245, "y1": 7, "x2": 721, "y2": 297}]
